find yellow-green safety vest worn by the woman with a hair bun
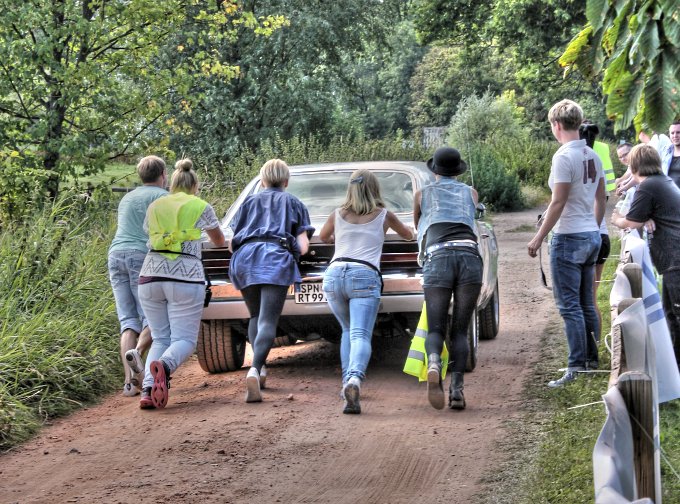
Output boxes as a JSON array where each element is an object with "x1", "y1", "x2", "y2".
[{"x1": 147, "y1": 192, "x2": 208, "y2": 261}]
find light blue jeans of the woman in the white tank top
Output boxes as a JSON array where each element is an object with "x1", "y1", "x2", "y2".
[{"x1": 323, "y1": 263, "x2": 380, "y2": 383}]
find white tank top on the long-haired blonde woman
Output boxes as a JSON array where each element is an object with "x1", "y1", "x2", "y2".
[{"x1": 331, "y1": 208, "x2": 387, "y2": 269}]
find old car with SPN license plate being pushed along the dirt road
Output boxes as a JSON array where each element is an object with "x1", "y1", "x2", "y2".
[{"x1": 197, "y1": 161, "x2": 499, "y2": 373}]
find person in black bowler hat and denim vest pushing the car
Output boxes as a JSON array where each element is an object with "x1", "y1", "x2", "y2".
[{"x1": 413, "y1": 147, "x2": 482, "y2": 409}]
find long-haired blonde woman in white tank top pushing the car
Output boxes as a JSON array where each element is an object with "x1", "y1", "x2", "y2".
[{"x1": 319, "y1": 170, "x2": 416, "y2": 414}]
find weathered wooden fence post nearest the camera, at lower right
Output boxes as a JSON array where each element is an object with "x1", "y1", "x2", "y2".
[{"x1": 616, "y1": 371, "x2": 657, "y2": 502}]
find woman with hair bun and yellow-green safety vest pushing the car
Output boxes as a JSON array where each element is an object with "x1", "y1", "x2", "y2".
[{"x1": 139, "y1": 159, "x2": 225, "y2": 409}]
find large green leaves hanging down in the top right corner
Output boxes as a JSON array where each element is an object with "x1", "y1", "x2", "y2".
[{"x1": 560, "y1": 0, "x2": 680, "y2": 131}]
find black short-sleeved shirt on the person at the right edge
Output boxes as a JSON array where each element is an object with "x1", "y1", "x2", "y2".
[{"x1": 626, "y1": 175, "x2": 680, "y2": 274}]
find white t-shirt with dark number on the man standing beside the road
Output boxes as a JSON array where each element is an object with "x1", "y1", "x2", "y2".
[{"x1": 548, "y1": 140, "x2": 604, "y2": 234}]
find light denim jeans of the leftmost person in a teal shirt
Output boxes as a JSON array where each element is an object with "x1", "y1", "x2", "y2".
[{"x1": 108, "y1": 250, "x2": 147, "y2": 334}]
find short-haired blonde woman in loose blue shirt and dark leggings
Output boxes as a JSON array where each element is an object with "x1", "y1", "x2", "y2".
[{"x1": 229, "y1": 159, "x2": 314, "y2": 402}]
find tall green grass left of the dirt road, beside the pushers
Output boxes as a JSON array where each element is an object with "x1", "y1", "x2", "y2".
[{"x1": 0, "y1": 198, "x2": 120, "y2": 449}]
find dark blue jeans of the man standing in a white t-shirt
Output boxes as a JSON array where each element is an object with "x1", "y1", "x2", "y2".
[{"x1": 550, "y1": 231, "x2": 601, "y2": 371}]
